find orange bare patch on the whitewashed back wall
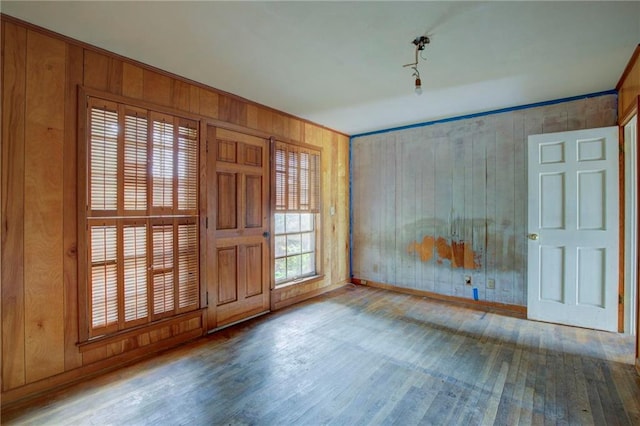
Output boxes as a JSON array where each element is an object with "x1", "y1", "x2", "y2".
[{"x1": 407, "y1": 235, "x2": 480, "y2": 269}]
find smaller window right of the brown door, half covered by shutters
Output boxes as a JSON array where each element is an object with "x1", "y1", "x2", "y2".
[{"x1": 274, "y1": 142, "x2": 320, "y2": 285}]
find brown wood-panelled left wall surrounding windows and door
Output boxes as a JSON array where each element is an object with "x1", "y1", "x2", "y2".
[{"x1": 0, "y1": 16, "x2": 349, "y2": 404}]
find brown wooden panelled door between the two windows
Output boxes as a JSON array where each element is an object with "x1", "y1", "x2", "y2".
[{"x1": 207, "y1": 126, "x2": 271, "y2": 330}]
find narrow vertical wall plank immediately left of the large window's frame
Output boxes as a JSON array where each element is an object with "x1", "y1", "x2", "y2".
[{"x1": 63, "y1": 44, "x2": 85, "y2": 370}]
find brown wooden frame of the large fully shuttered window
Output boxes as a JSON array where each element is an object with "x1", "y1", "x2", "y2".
[{"x1": 76, "y1": 90, "x2": 206, "y2": 345}]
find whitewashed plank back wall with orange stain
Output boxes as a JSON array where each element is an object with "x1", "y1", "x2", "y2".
[{"x1": 352, "y1": 94, "x2": 617, "y2": 306}]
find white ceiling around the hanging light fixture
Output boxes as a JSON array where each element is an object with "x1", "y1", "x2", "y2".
[{"x1": 0, "y1": 0, "x2": 640, "y2": 134}]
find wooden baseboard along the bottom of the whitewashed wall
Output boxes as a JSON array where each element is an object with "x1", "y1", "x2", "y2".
[{"x1": 351, "y1": 278, "x2": 527, "y2": 318}]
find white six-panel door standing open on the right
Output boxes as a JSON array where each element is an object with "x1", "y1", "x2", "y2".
[{"x1": 527, "y1": 127, "x2": 619, "y2": 331}]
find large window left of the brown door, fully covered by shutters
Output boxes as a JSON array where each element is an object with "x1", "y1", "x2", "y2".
[{"x1": 82, "y1": 98, "x2": 200, "y2": 338}]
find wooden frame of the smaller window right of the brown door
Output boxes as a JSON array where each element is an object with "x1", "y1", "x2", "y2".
[{"x1": 271, "y1": 138, "x2": 323, "y2": 289}]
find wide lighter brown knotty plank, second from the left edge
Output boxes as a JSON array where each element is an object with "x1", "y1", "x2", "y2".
[{"x1": 24, "y1": 31, "x2": 66, "y2": 382}]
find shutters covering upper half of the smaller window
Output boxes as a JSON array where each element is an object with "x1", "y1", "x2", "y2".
[{"x1": 274, "y1": 142, "x2": 320, "y2": 213}]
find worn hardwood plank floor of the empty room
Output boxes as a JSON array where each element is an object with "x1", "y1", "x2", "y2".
[{"x1": 1, "y1": 285, "x2": 640, "y2": 425}]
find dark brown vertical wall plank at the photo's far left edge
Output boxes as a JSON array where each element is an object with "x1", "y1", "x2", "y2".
[{"x1": 1, "y1": 22, "x2": 27, "y2": 391}]
